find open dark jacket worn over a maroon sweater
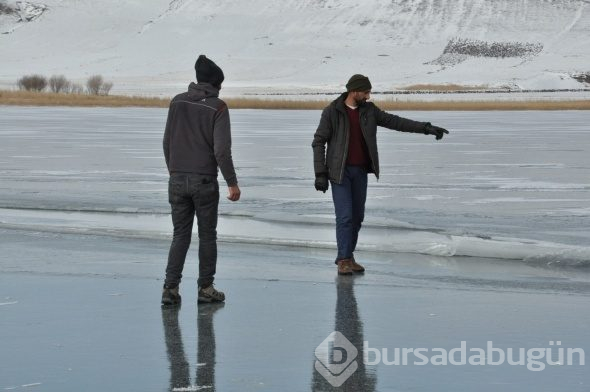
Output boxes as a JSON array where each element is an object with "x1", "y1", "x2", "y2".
[{"x1": 311, "y1": 93, "x2": 426, "y2": 184}]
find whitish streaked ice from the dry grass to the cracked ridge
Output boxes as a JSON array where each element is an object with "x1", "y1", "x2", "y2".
[{"x1": 0, "y1": 107, "x2": 590, "y2": 265}]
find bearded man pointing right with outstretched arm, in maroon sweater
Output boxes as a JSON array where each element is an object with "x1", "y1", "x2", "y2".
[{"x1": 311, "y1": 74, "x2": 449, "y2": 275}]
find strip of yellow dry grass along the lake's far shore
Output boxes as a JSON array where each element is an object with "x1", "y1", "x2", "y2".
[{"x1": 0, "y1": 91, "x2": 590, "y2": 111}]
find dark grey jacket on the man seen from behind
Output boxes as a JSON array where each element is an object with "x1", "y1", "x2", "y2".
[{"x1": 164, "y1": 83, "x2": 238, "y2": 186}]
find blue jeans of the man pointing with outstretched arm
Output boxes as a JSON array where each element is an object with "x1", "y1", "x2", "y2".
[{"x1": 332, "y1": 166, "x2": 367, "y2": 261}]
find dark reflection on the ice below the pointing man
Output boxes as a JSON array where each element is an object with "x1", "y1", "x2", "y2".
[{"x1": 311, "y1": 276, "x2": 377, "y2": 392}]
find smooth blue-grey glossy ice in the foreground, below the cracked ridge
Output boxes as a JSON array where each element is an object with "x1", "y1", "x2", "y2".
[{"x1": 0, "y1": 247, "x2": 590, "y2": 392}]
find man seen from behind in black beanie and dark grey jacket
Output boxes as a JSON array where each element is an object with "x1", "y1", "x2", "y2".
[{"x1": 162, "y1": 55, "x2": 240, "y2": 305}]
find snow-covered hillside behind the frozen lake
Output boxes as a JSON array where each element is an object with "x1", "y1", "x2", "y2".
[{"x1": 0, "y1": 0, "x2": 590, "y2": 95}]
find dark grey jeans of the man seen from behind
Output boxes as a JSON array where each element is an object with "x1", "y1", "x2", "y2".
[{"x1": 165, "y1": 174, "x2": 219, "y2": 287}]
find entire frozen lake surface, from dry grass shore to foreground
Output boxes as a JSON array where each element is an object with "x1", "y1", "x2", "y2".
[{"x1": 0, "y1": 107, "x2": 590, "y2": 392}]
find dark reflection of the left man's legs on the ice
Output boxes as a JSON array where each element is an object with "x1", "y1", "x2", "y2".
[{"x1": 162, "y1": 302, "x2": 224, "y2": 391}]
